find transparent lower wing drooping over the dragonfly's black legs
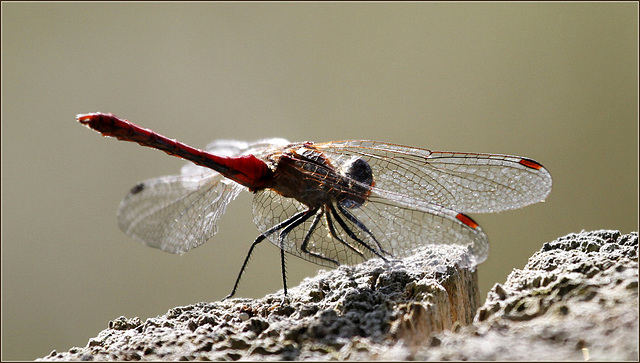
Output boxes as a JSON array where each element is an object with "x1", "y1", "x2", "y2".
[{"x1": 253, "y1": 190, "x2": 489, "y2": 267}]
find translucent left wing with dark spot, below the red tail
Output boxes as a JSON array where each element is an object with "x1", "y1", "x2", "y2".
[{"x1": 118, "y1": 172, "x2": 245, "y2": 253}]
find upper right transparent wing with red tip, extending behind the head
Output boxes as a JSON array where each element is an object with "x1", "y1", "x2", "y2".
[{"x1": 315, "y1": 140, "x2": 552, "y2": 213}]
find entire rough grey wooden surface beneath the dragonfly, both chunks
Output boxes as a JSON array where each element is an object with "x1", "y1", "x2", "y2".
[{"x1": 38, "y1": 231, "x2": 638, "y2": 360}]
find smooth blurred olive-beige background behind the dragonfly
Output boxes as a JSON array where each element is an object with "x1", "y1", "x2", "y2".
[{"x1": 2, "y1": 2, "x2": 638, "y2": 360}]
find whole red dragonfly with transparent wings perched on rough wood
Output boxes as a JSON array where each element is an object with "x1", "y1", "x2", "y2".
[{"x1": 77, "y1": 113, "x2": 552, "y2": 299}]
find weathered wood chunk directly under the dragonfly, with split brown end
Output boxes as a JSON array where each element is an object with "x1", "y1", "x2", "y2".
[{"x1": 38, "y1": 242, "x2": 479, "y2": 360}]
